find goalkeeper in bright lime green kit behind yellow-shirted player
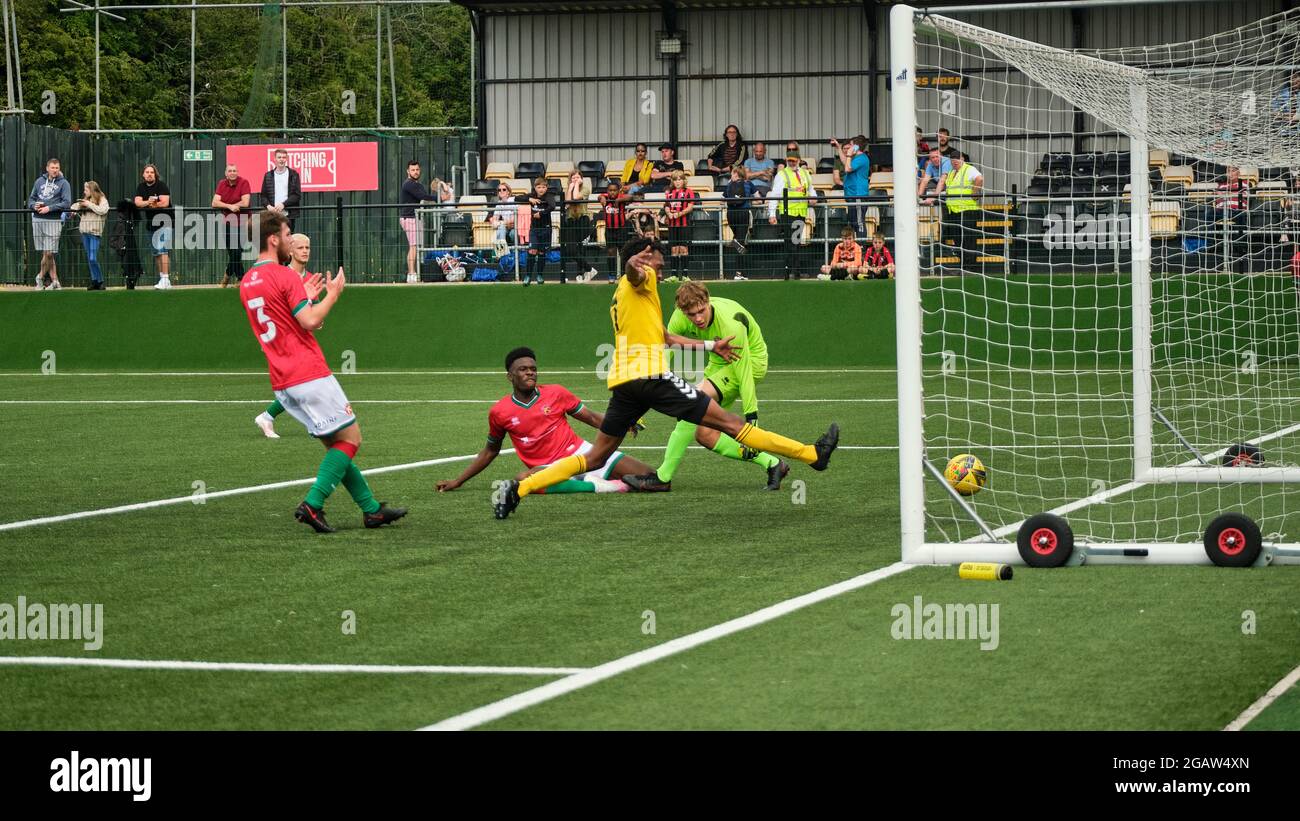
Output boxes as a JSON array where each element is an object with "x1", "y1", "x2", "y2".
[{"x1": 623, "y1": 282, "x2": 790, "y2": 491}]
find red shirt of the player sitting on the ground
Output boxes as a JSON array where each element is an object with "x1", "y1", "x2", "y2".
[{"x1": 488, "y1": 385, "x2": 582, "y2": 468}]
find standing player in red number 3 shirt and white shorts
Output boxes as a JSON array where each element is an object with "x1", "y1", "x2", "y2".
[{"x1": 239, "y1": 213, "x2": 406, "y2": 533}]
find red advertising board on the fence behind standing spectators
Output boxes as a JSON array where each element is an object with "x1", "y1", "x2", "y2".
[{"x1": 226, "y1": 143, "x2": 380, "y2": 191}]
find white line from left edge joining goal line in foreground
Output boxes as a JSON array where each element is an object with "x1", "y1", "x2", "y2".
[{"x1": 0, "y1": 656, "x2": 588, "y2": 676}]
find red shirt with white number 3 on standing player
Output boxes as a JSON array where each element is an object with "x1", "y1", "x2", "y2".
[{"x1": 239, "y1": 261, "x2": 329, "y2": 391}]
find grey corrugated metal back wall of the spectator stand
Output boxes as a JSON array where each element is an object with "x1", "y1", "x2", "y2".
[{"x1": 484, "y1": 0, "x2": 1284, "y2": 176}]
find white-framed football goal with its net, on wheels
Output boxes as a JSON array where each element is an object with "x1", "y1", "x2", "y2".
[{"x1": 891, "y1": 6, "x2": 1300, "y2": 562}]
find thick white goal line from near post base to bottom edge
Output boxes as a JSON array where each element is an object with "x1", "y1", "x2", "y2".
[{"x1": 420, "y1": 561, "x2": 918, "y2": 730}]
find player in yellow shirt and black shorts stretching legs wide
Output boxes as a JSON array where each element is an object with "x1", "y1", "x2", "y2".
[{"x1": 493, "y1": 239, "x2": 840, "y2": 518}]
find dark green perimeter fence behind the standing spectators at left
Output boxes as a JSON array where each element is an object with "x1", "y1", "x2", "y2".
[{"x1": 0, "y1": 116, "x2": 477, "y2": 286}]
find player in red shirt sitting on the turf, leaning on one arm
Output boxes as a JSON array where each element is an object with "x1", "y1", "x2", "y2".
[{"x1": 438, "y1": 348, "x2": 660, "y2": 494}]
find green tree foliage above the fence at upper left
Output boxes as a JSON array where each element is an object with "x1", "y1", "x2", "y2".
[{"x1": 17, "y1": 0, "x2": 472, "y2": 130}]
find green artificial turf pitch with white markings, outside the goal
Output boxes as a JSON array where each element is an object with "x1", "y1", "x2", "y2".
[{"x1": 0, "y1": 361, "x2": 1300, "y2": 729}]
